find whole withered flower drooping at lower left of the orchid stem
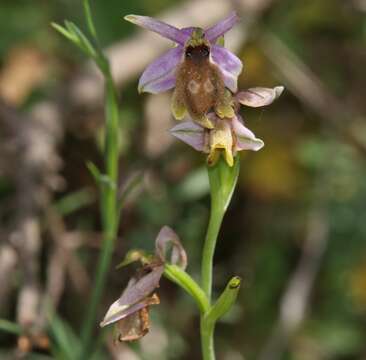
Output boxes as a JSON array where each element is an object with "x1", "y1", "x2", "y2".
[{"x1": 100, "y1": 226, "x2": 187, "y2": 341}]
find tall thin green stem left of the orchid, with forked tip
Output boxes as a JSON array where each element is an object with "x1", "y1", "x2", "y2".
[{"x1": 52, "y1": 4, "x2": 120, "y2": 360}]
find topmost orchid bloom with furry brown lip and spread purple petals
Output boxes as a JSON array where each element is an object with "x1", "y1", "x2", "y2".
[{"x1": 125, "y1": 12, "x2": 243, "y2": 128}]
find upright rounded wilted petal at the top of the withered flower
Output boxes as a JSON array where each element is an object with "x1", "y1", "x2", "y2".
[{"x1": 155, "y1": 226, "x2": 187, "y2": 270}]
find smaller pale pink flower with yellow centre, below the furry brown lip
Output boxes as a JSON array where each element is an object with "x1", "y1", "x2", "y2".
[{"x1": 170, "y1": 86, "x2": 284, "y2": 166}]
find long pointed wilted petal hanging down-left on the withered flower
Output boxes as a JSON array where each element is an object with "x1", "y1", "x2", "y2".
[{"x1": 100, "y1": 264, "x2": 164, "y2": 326}]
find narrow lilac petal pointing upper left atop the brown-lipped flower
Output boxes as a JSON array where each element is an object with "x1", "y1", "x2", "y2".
[{"x1": 125, "y1": 15, "x2": 189, "y2": 45}]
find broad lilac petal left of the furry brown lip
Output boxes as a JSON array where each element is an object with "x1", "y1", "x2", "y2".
[{"x1": 138, "y1": 45, "x2": 184, "y2": 94}]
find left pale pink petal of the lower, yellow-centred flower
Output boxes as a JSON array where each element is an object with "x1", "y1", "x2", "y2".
[{"x1": 170, "y1": 121, "x2": 205, "y2": 151}]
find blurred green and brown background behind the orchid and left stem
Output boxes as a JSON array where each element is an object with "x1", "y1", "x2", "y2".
[{"x1": 0, "y1": 0, "x2": 366, "y2": 360}]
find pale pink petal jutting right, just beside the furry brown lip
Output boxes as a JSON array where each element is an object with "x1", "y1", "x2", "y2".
[{"x1": 236, "y1": 86, "x2": 285, "y2": 107}]
